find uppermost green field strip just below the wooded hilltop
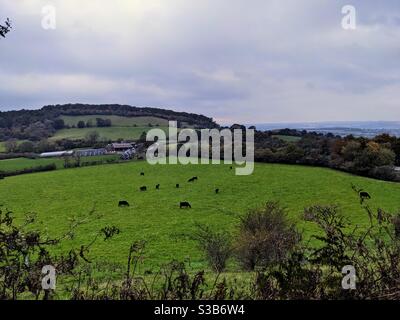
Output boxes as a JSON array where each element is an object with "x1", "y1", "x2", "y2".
[{"x1": 60, "y1": 115, "x2": 168, "y2": 127}]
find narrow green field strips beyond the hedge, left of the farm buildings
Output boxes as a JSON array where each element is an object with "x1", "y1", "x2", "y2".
[{"x1": 0, "y1": 155, "x2": 119, "y2": 172}]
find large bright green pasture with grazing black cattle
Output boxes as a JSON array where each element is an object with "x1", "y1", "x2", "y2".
[{"x1": 0, "y1": 162, "x2": 400, "y2": 272}]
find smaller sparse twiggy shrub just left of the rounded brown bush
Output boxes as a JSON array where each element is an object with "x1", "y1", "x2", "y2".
[{"x1": 192, "y1": 224, "x2": 232, "y2": 272}]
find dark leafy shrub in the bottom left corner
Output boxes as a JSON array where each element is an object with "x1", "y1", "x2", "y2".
[{"x1": 0, "y1": 207, "x2": 78, "y2": 300}]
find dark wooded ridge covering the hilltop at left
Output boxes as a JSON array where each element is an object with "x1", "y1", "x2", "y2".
[{"x1": 0, "y1": 104, "x2": 218, "y2": 142}]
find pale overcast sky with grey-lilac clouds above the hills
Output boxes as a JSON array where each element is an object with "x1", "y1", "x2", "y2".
[{"x1": 0, "y1": 0, "x2": 400, "y2": 124}]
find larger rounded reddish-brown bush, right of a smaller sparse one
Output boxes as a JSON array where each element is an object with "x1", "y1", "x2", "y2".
[{"x1": 236, "y1": 202, "x2": 300, "y2": 270}]
